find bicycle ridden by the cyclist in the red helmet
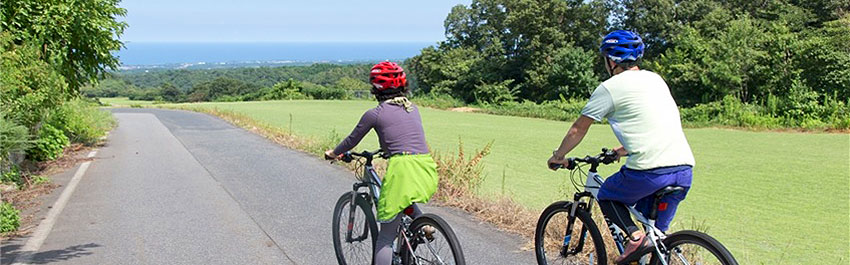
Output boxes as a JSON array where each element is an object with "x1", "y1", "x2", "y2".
[{"x1": 333, "y1": 150, "x2": 466, "y2": 265}]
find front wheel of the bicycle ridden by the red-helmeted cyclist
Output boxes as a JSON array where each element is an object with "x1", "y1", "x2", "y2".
[{"x1": 332, "y1": 192, "x2": 378, "y2": 265}]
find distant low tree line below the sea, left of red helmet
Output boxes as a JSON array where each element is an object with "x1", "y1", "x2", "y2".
[{"x1": 88, "y1": 64, "x2": 371, "y2": 102}]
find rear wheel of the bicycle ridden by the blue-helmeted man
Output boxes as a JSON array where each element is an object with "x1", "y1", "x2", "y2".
[{"x1": 650, "y1": 230, "x2": 738, "y2": 265}]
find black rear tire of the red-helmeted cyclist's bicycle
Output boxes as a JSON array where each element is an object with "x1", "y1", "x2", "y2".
[{"x1": 399, "y1": 213, "x2": 466, "y2": 265}]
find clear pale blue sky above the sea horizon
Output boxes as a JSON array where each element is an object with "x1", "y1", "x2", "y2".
[{"x1": 121, "y1": 0, "x2": 471, "y2": 42}]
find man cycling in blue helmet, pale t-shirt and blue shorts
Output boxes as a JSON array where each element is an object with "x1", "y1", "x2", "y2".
[{"x1": 548, "y1": 30, "x2": 694, "y2": 262}]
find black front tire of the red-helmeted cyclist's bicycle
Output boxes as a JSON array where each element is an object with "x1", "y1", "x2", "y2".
[{"x1": 332, "y1": 191, "x2": 378, "y2": 265}]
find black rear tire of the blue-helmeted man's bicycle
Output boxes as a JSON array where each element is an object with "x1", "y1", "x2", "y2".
[{"x1": 650, "y1": 230, "x2": 738, "y2": 265}]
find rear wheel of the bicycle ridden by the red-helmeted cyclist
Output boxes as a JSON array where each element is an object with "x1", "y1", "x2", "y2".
[{"x1": 400, "y1": 213, "x2": 466, "y2": 265}]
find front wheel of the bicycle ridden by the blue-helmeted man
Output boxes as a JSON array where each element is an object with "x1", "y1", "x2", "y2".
[{"x1": 534, "y1": 201, "x2": 608, "y2": 265}]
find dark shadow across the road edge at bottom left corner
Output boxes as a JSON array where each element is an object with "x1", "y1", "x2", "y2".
[{"x1": 0, "y1": 243, "x2": 101, "y2": 265}]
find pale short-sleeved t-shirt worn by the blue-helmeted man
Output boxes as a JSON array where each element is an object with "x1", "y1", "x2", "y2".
[{"x1": 581, "y1": 70, "x2": 694, "y2": 170}]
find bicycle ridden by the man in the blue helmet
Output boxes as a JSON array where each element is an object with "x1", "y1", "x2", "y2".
[{"x1": 534, "y1": 148, "x2": 738, "y2": 265}]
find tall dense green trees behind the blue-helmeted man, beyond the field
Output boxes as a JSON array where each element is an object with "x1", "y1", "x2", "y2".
[{"x1": 400, "y1": 0, "x2": 850, "y2": 129}]
